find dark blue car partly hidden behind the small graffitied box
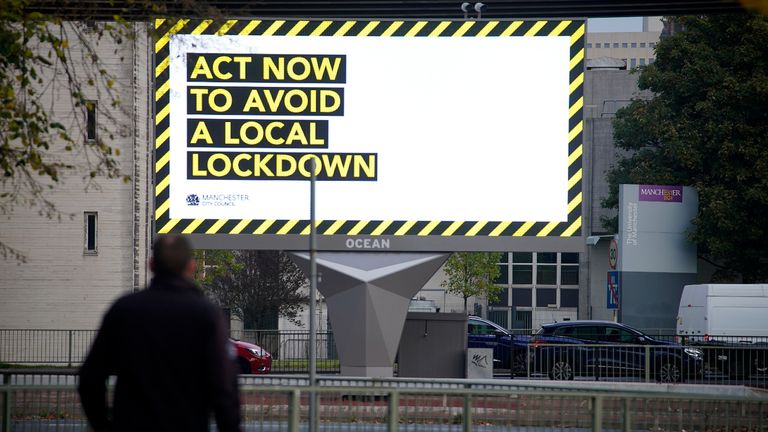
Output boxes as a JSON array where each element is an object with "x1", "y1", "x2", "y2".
[{"x1": 467, "y1": 316, "x2": 531, "y2": 375}]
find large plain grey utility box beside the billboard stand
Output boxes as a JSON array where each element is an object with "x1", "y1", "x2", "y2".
[{"x1": 397, "y1": 312, "x2": 467, "y2": 378}]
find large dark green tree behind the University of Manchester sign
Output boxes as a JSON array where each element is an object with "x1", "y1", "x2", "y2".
[{"x1": 603, "y1": 14, "x2": 768, "y2": 282}]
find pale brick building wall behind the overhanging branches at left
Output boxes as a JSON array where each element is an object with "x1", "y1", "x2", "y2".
[{"x1": 0, "y1": 24, "x2": 152, "y2": 329}]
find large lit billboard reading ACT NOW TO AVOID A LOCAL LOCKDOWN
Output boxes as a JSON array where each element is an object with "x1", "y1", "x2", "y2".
[{"x1": 154, "y1": 19, "x2": 584, "y2": 251}]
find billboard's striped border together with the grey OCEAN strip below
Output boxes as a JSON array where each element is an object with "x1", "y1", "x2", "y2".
[{"x1": 153, "y1": 19, "x2": 585, "y2": 252}]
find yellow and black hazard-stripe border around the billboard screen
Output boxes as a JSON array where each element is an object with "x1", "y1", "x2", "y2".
[{"x1": 154, "y1": 19, "x2": 585, "y2": 237}]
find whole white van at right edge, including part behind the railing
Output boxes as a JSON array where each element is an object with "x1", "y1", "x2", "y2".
[{"x1": 677, "y1": 284, "x2": 768, "y2": 379}]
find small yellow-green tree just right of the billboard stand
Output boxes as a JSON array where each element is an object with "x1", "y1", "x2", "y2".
[{"x1": 440, "y1": 252, "x2": 502, "y2": 312}]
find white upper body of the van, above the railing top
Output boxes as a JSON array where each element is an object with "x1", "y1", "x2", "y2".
[{"x1": 677, "y1": 284, "x2": 768, "y2": 343}]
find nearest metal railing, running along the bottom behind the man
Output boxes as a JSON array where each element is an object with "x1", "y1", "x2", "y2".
[{"x1": 0, "y1": 377, "x2": 768, "y2": 432}]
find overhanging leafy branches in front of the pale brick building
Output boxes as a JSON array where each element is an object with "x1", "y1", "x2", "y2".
[{"x1": 0, "y1": 0, "x2": 134, "y2": 260}]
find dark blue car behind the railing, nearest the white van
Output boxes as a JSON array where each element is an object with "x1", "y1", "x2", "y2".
[{"x1": 531, "y1": 321, "x2": 703, "y2": 382}]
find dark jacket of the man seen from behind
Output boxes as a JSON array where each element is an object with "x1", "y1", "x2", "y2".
[{"x1": 78, "y1": 278, "x2": 240, "y2": 432}]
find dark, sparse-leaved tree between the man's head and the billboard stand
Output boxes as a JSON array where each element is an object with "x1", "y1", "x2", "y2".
[{"x1": 203, "y1": 250, "x2": 308, "y2": 329}]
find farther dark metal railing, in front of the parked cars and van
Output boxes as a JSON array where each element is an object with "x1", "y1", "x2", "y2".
[{"x1": 0, "y1": 329, "x2": 768, "y2": 388}]
